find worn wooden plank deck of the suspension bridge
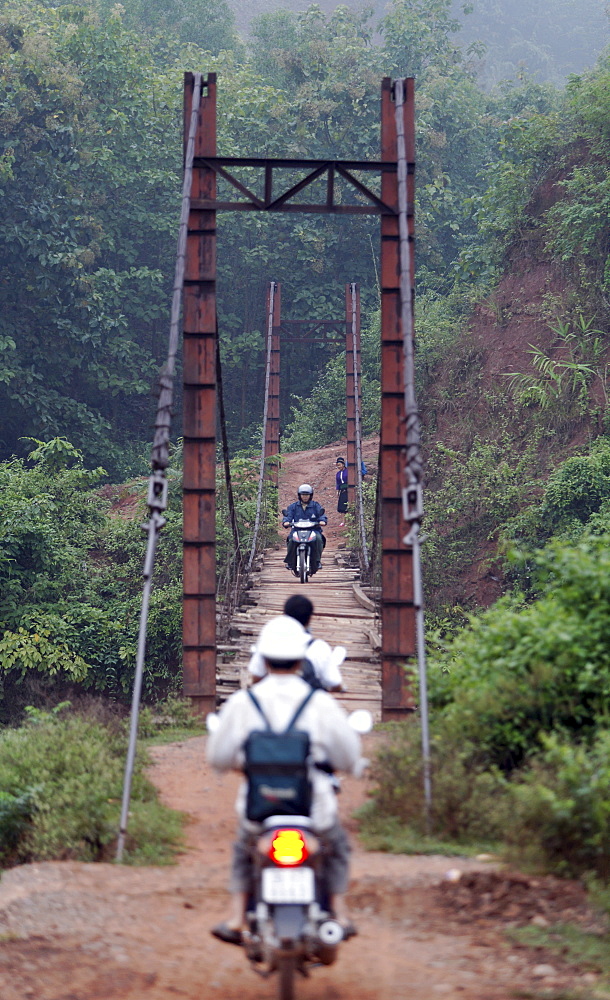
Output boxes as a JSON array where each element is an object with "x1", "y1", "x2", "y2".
[{"x1": 217, "y1": 538, "x2": 381, "y2": 721}]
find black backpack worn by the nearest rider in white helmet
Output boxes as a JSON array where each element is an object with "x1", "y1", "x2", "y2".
[{"x1": 244, "y1": 689, "x2": 315, "y2": 823}]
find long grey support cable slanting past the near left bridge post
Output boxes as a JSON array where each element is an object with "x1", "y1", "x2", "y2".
[{"x1": 116, "y1": 73, "x2": 203, "y2": 861}]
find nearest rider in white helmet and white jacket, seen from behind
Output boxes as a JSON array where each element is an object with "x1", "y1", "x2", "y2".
[{"x1": 207, "y1": 615, "x2": 361, "y2": 944}]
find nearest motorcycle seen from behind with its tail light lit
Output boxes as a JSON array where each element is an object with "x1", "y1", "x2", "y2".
[{"x1": 207, "y1": 709, "x2": 373, "y2": 1000}]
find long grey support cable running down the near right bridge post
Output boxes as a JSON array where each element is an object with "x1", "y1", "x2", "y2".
[{"x1": 394, "y1": 80, "x2": 432, "y2": 826}]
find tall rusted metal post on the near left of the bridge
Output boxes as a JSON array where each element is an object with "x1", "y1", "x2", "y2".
[{"x1": 183, "y1": 73, "x2": 216, "y2": 714}]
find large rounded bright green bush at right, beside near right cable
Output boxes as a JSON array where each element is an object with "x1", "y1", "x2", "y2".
[{"x1": 431, "y1": 538, "x2": 610, "y2": 769}]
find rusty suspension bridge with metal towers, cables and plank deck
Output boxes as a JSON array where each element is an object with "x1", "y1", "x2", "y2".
[{"x1": 141, "y1": 73, "x2": 422, "y2": 719}]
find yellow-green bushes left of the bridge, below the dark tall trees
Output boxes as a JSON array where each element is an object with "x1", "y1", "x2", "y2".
[{"x1": 0, "y1": 440, "x2": 286, "y2": 719}]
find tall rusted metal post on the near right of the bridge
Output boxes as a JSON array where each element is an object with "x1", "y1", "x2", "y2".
[{"x1": 380, "y1": 77, "x2": 416, "y2": 720}]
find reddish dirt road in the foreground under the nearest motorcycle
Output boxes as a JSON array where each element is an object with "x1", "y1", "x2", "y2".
[{"x1": 0, "y1": 734, "x2": 595, "y2": 1000}]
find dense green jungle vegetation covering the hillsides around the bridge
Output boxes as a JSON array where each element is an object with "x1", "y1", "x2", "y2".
[{"x1": 0, "y1": 0, "x2": 610, "y2": 879}]
